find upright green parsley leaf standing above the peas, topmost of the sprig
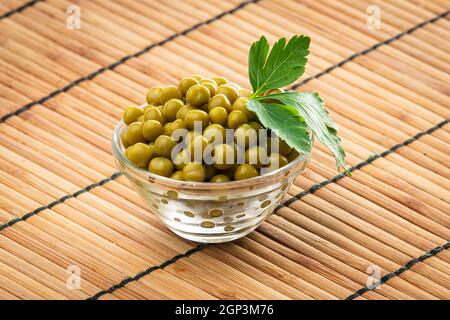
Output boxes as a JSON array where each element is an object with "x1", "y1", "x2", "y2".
[{"x1": 248, "y1": 36, "x2": 310, "y2": 96}]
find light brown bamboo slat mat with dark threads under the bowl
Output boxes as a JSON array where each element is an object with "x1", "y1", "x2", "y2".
[{"x1": 0, "y1": 0, "x2": 450, "y2": 299}]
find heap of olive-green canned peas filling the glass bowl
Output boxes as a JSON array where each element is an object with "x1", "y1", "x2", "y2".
[{"x1": 121, "y1": 75, "x2": 298, "y2": 183}]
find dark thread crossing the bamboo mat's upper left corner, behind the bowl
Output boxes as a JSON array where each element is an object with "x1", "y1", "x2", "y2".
[{"x1": 0, "y1": 0, "x2": 261, "y2": 123}]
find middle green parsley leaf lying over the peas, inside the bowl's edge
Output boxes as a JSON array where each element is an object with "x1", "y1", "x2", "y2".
[{"x1": 247, "y1": 99, "x2": 312, "y2": 154}]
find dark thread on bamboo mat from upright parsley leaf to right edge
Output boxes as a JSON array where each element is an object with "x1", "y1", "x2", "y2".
[{"x1": 289, "y1": 10, "x2": 450, "y2": 90}]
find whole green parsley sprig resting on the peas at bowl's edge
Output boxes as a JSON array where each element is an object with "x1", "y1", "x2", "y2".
[{"x1": 248, "y1": 36, "x2": 348, "y2": 173}]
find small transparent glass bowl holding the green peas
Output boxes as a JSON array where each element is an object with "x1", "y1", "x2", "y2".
[{"x1": 112, "y1": 115, "x2": 310, "y2": 243}]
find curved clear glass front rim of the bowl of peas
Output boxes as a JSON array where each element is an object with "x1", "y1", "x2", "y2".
[{"x1": 111, "y1": 104, "x2": 314, "y2": 189}]
